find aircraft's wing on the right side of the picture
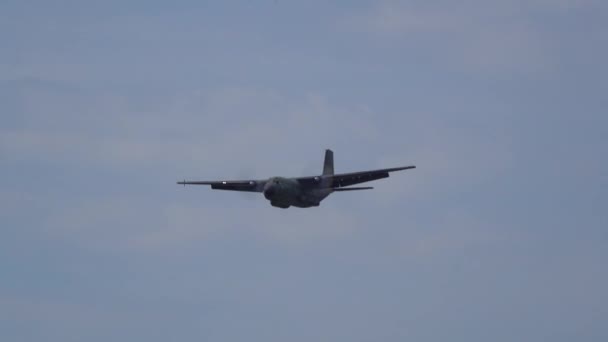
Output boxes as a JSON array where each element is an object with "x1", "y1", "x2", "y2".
[{"x1": 296, "y1": 165, "x2": 416, "y2": 188}]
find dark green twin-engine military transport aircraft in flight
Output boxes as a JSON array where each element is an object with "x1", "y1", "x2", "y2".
[{"x1": 177, "y1": 150, "x2": 416, "y2": 209}]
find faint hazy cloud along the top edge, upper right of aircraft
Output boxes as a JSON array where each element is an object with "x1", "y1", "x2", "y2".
[{"x1": 340, "y1": 0, "x2": 595, "y2": 74}]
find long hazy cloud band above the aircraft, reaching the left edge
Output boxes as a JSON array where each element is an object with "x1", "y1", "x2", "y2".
[{"x1": 0, "y1": 86, "x2": 377, "y2": 171}]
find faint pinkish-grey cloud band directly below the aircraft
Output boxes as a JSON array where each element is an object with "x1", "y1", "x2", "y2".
[{"x1": 37, "y1": 194, "x2": 366, "y2": 253}]
